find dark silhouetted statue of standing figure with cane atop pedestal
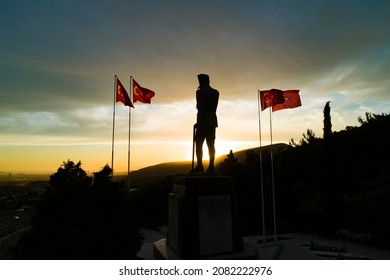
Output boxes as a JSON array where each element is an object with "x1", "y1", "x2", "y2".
[{"x1": 193, "y1": 74, "x2": 219, "y2": 172}]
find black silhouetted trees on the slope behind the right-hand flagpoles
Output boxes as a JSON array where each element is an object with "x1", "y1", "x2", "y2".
[{"x1": 219, "y1": 111, "x2": 390, "y2": 246}]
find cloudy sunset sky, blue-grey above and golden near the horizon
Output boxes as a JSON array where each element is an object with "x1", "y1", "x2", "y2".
[{"x1": 0, "y1": 0, "x2": 390, "y2": 175}]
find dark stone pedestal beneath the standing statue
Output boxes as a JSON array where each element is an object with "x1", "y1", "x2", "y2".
[{"x1": 166, "y1": 176, "x2": 244, "y2": 259}]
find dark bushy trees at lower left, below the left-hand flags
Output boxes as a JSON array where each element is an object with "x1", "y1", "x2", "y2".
[{"x1": 13, "y1": 160, "x2": 143, "y2": 260}]
